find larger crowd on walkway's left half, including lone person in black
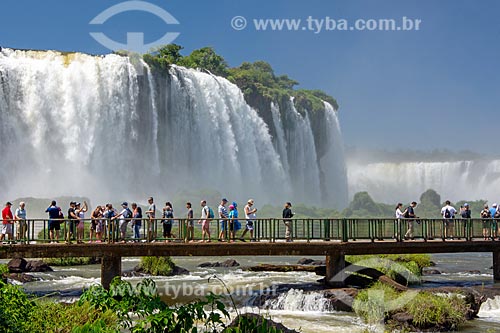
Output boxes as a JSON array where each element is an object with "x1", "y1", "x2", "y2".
[{"x1": 0, "y1": 197, "x2": 294, "y2": 244}]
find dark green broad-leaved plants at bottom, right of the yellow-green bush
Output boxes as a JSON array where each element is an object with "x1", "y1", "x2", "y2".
[{"x1": 79, "y1": 278, "x2": 288, "y2": 333}]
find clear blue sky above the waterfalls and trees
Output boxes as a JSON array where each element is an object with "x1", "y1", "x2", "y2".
[{"x1": 0, "y1": 0, "x2": 500, "y2": 153}]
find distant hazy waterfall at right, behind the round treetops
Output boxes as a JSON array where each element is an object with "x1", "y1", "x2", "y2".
[{"x1": 348, "y1": 160, "x2": 500, "y2": 203}]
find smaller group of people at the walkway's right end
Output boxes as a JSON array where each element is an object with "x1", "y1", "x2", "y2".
[{"x1": 395, "y1": 200, "x2": 500, "y2": 240}]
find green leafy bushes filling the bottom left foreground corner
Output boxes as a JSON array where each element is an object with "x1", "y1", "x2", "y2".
[{"x1": 0, "y1": 278, "x2": 290, "y2": 333}]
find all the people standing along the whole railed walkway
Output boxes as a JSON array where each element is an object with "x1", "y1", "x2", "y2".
[{"x1": 0, "y1": 197, "x2": 500, "y2": 243}]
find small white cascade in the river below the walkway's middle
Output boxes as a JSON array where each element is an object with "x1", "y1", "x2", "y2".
[{"x1": 264, "y1": 289, "x2": 332, "y2": 312}]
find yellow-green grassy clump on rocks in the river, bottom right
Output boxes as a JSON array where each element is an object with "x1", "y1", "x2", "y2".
[{"x1": 353, "y1": 283, "x2": 468, "y2": 330}]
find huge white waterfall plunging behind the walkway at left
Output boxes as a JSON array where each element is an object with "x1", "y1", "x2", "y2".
[{"x1": 0, "y1": 49, "x2": 347, "y2": 204}]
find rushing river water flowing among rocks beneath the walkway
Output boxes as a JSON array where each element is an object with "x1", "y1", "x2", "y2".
[{"x1": 3, "y1": 253, "x2": 500, "y2": 333}]
